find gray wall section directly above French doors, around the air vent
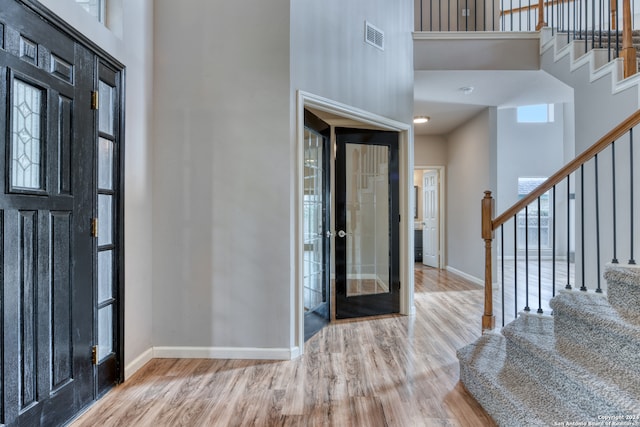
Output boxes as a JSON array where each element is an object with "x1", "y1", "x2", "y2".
[{"x1": 292, "y1": 0, "x2": 413, "y2": 124}]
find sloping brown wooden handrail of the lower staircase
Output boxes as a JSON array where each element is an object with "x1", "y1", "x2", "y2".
[{"x1": 491, "y1": 110, "x2": 640, "y2": 230}]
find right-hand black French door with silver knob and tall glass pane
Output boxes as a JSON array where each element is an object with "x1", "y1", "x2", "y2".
[{"x1": 335, "y1": 128, "x2": 400, "y2": 319}]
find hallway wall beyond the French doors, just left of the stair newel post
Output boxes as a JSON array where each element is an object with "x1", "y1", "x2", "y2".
[{"x1": 447, "y1": 107, "x2": 497, "y2": 280}]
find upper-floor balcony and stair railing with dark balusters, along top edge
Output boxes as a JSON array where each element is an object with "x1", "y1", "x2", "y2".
[{"x1": 415, "y1": 0, "x2": 637, "y2": 77}]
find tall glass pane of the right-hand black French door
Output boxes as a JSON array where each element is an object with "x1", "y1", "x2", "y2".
[{"x1": 345, "y1": 144, "x2": 390, "y2": 297}]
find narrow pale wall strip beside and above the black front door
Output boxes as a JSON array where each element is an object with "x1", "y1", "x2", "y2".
[{"x1": 40, "y1": 0, "x2": 153, "y2": 372}]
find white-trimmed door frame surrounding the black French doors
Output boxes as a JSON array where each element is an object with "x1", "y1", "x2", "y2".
[{"x1": 298, "y1": 91, "x2": 414, "y2": 354}]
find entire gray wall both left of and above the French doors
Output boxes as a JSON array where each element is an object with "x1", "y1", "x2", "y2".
[{"x1": 153, "y1": 0, "x2": 413, "y2": 348}]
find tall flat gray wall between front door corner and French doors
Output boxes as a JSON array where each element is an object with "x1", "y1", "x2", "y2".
[{"x1": 153, "y1": 0, "x2": 293, "y2": 348}]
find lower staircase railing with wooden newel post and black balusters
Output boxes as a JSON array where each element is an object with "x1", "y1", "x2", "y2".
[{"x1": 482, "y1": 110, "x2": 640, "y2": 331}]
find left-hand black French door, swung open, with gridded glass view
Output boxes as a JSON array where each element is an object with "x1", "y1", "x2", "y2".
[{"x1": 303, "y1": 110, "x2": 330, "y2": 341}]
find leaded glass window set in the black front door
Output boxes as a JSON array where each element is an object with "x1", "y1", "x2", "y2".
[{"x1": 11, "y1": 79, "x2": 43, "y2": 190}]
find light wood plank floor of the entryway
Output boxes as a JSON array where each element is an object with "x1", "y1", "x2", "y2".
[{"x1": 72, "y1": 264, "x2": 495, "y2": 427}]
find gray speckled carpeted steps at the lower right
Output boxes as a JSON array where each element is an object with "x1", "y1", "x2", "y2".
[{"x1": 458, "y1": 265, "x2": 640, "y2": 427}]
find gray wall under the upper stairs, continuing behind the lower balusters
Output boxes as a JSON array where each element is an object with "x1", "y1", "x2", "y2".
[{"x1": 541, "y1": 44, "x2": 640, "y2": 289}]
